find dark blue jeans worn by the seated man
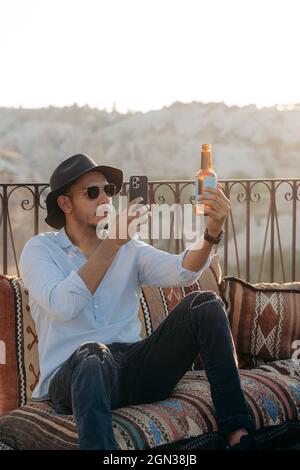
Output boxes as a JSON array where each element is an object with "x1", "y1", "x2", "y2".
[{"x1": 49, "y1": 291, "x2": 252, "y2": 450}]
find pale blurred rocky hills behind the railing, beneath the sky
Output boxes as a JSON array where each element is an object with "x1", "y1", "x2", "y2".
[{"x1": 0, "y1": 102, "x2": 300, "y2": 182}]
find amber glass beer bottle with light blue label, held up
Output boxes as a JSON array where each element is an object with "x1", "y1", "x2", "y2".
[{"x1": 195, "y1": 144, "x2": 217, "y2": 215}]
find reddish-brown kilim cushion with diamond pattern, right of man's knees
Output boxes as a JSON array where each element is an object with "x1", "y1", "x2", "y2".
[{"x1": 221, "y1": 277, "x2": 300, "y2": 367}]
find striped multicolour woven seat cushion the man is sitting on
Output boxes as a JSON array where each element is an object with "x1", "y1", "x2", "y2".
[{"x1": 0, "y1": 360, "x2": 300, "y2": 450}]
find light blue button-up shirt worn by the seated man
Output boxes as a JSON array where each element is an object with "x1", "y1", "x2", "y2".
[{"x1": 20, "y1": 228, "x2": 209, "y2": 399}]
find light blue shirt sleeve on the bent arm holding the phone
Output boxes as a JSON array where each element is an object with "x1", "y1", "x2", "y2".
[{"x1": 20, "y1": 239, "x2": 92, "y2": 322}]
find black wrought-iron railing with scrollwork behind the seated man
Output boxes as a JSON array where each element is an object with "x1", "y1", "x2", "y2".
[{"x1": 0, "y1": 178, "x2": 300, "y2": 282}]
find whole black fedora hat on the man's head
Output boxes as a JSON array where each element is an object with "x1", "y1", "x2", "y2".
[{"x1": 45, "y1": 153, "x2": 123, "y2": 229}]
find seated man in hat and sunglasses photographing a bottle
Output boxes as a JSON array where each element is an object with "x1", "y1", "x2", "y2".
[{"x1": 20, "y1": 154, "x2": 252, "y2": 449}]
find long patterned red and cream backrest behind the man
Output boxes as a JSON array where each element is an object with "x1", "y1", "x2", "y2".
[{"x1": 0, "y1": 255, "x2": 221, "y2": 416}]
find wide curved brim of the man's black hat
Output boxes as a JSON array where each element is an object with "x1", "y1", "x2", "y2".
[{"x1": 45, "y1": 165, "x2": 123, "y2": 229}]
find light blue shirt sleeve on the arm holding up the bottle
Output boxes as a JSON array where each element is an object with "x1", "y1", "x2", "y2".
[{"x1": 135, "y1": 241, "x2": 210, "y2": 287}]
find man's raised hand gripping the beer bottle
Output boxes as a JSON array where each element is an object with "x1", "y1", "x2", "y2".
[{"x1": 198, "y1": 183, "x2": 230, "y2": 237}]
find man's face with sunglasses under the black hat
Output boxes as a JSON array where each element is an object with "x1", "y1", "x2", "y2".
[{"x1": 62, "y1": 171, "x2": 112, "y2": 229}]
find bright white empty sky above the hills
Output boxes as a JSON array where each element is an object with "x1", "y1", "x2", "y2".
[{"x1": 0, "y1": 0, "x2": 300, "y2": 112}]
